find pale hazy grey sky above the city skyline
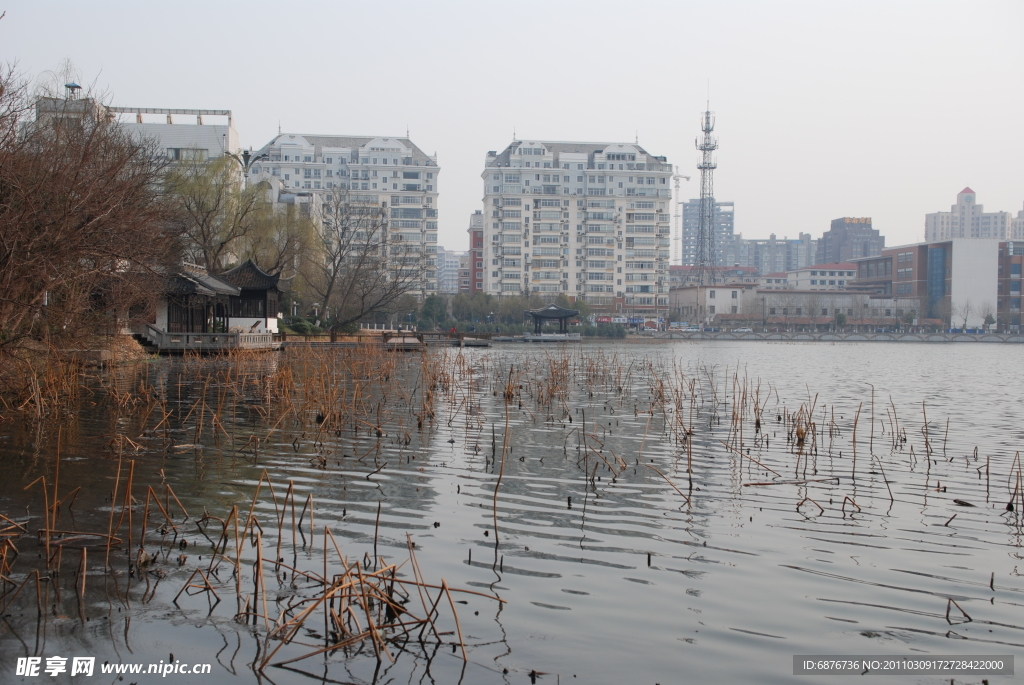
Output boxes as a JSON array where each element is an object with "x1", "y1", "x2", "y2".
[{"x1": 0, "y1": 0, "x2": 1024, "y2": 250}]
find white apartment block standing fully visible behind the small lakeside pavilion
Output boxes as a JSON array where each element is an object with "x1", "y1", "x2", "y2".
[{"x1": 481, "y1": 140, "x2": 673, "y2": 319}]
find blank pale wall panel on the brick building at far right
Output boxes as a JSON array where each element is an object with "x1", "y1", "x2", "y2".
[{"x1": 950, "y1": 239, "x2": 999, "y2": 328}]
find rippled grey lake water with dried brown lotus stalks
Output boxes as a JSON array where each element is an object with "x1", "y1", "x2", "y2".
[{"x1": 0, "y1": 343, "x2": 1024, "y2": 683}]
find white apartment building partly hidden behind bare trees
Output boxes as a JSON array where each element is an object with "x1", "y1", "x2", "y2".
[{"x1": 250, "y1": 133, "x2": 440, "y2": 300}]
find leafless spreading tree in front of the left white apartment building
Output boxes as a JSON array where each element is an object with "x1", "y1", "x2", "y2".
[{"x1": 300, "y1": 189, "x2": 426, "y2": 331}]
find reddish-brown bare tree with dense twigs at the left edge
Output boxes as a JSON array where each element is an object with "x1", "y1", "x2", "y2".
[{"x1": 0, "y1": 68, "x2": 177, "y2": 349}]
